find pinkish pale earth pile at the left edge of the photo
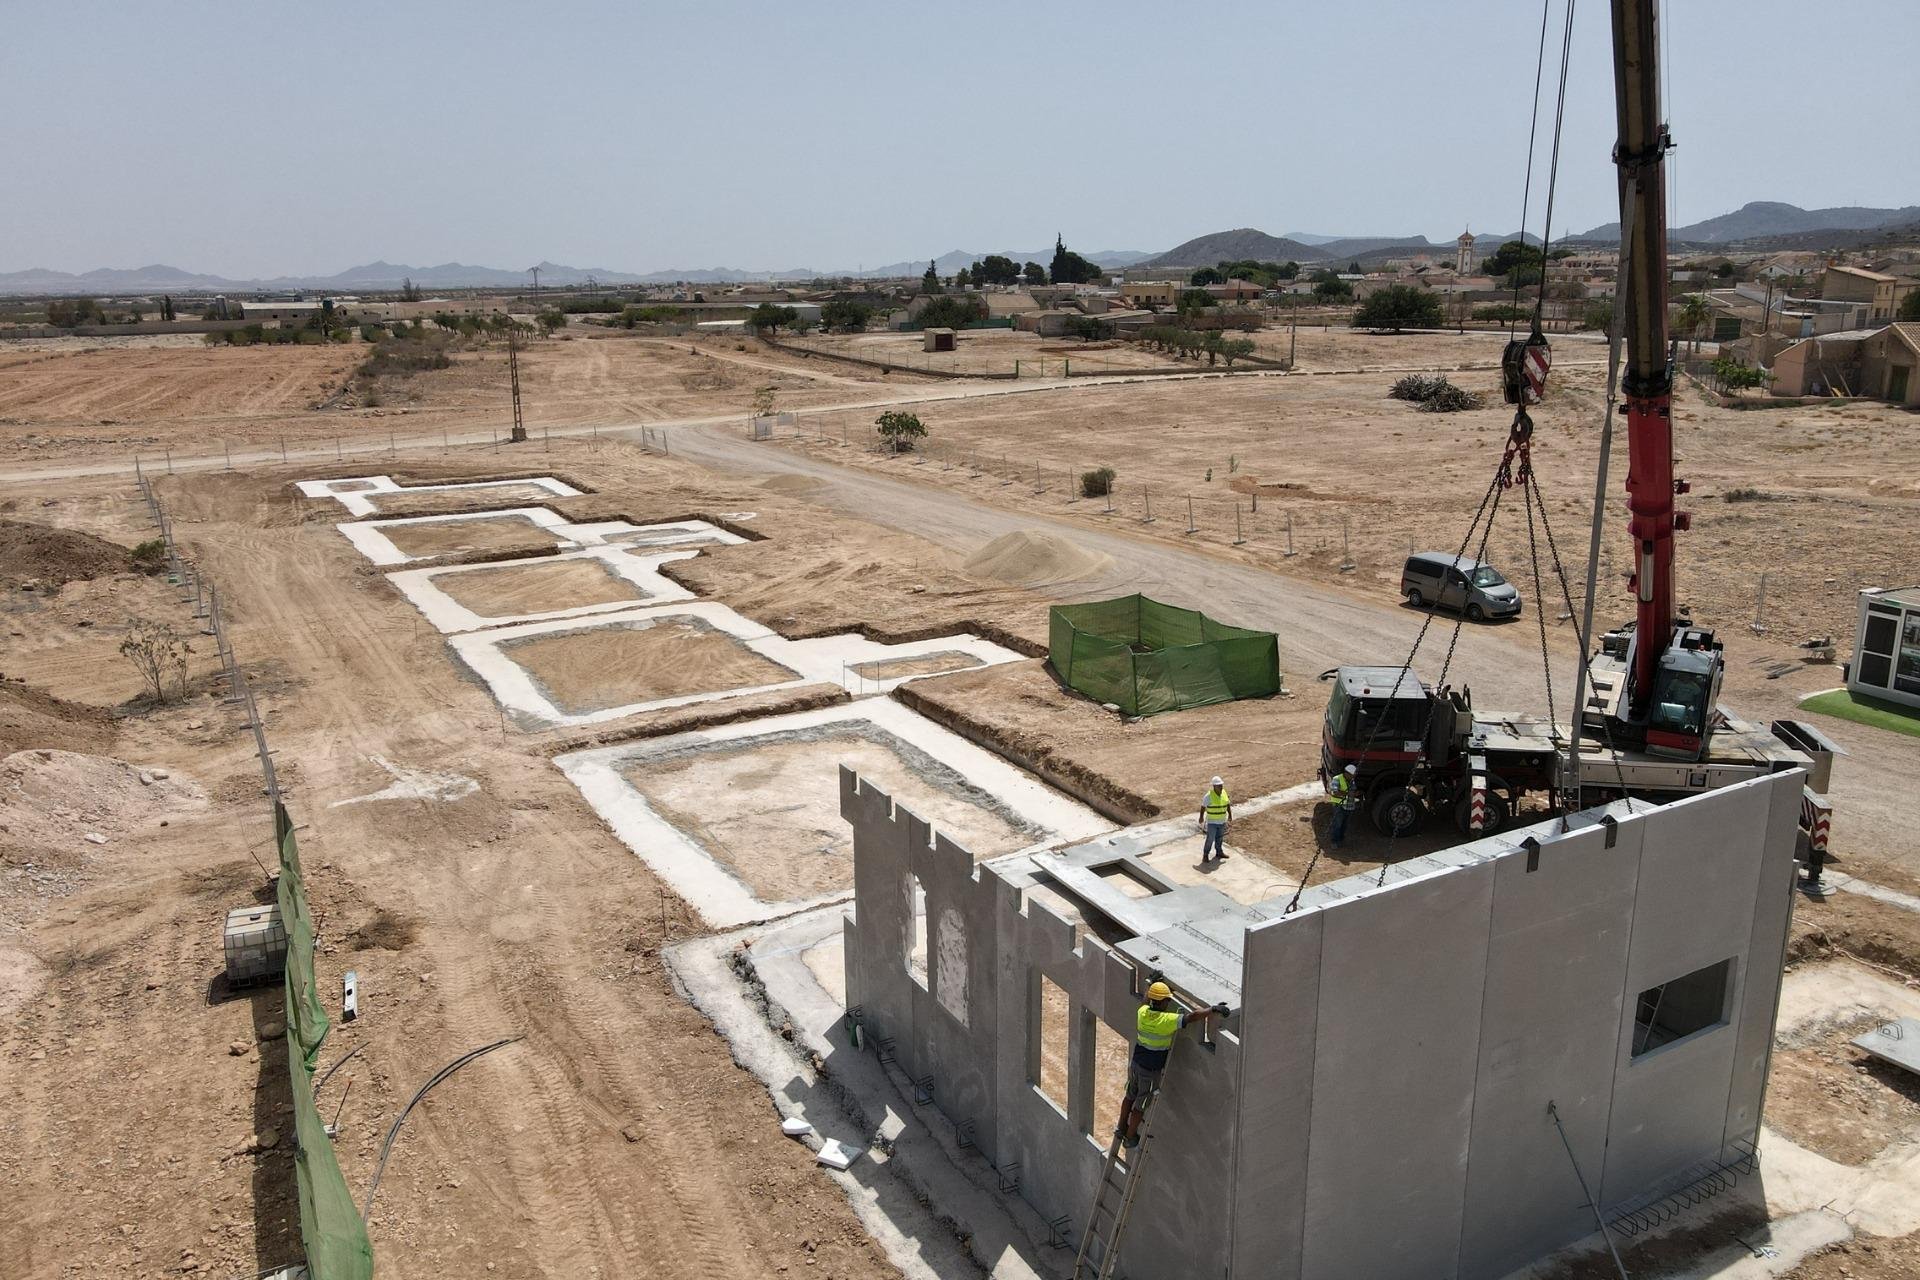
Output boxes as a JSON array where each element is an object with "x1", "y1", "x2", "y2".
[{"x1": 0, "y1": 750, "x2": 207, "y2": 862}]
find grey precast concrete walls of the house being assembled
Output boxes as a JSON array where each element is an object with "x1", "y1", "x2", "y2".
[{"x1": 843, "y1": 770, "x2": 1803, "y2": 1280}]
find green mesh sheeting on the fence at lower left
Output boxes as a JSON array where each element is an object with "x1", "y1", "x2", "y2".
[{"x1": 273, "y1": 804, "x2": 372, "y2": 1280}]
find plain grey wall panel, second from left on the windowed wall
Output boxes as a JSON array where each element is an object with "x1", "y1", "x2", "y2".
[{"x1": 1304, "y1": 864, "x2": 1494, "y2": 1280}]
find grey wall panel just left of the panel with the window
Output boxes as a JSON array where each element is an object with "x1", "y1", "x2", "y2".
[{"x1": 1459, "y1": 823, "x2": 1640, "y2": 1276}]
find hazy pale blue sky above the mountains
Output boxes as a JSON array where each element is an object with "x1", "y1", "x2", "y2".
[{"x1": 0, "y1": 0, "x2": 1920, "y2": 278}]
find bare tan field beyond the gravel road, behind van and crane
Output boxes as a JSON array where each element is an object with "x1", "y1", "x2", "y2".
[{"x1": 756, "y1": 330, "x2": 1920, "y2": 649}]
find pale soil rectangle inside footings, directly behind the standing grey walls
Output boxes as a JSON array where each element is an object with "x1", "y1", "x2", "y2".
[{"x1": 628, "y1": 731, "x2": 1033, "y2": 902}]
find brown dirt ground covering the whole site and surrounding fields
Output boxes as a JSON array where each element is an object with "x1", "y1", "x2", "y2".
[{"x1": 0, "y1": 322, "x2": 1920, "y2": 1280}]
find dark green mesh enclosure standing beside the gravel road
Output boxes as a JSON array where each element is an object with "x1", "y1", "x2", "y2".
[{"x1": 1046, "y1": 595, "x2": 1281, "y2": 716}]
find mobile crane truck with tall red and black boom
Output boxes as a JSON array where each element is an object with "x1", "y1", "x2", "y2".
[{"x1": 1321, "y1": 0, "x2": 1834, "y2": 835}]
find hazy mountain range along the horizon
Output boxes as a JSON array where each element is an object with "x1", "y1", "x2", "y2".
[{"x1": 0, "y1": 200, "x2": 1920, "y2": 294}]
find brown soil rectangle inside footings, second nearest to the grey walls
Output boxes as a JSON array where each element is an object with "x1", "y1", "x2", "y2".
[{"x1": 503, "y1": 618, "x2": 799, "y2": 716}]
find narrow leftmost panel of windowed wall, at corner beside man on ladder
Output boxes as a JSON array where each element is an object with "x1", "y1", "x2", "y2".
[{"x1": 1231, "y1": 912, "x2": 1327, "y2": 1280}]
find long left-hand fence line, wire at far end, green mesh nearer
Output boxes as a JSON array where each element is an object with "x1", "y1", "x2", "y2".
[{"x1": 134, "y1": 459, "x2": 372, "y2": 1280}]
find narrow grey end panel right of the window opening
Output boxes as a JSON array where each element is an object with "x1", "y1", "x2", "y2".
[{"x1": 1722, "y1": 773, "x2": 1803, "y2": 1159}]
